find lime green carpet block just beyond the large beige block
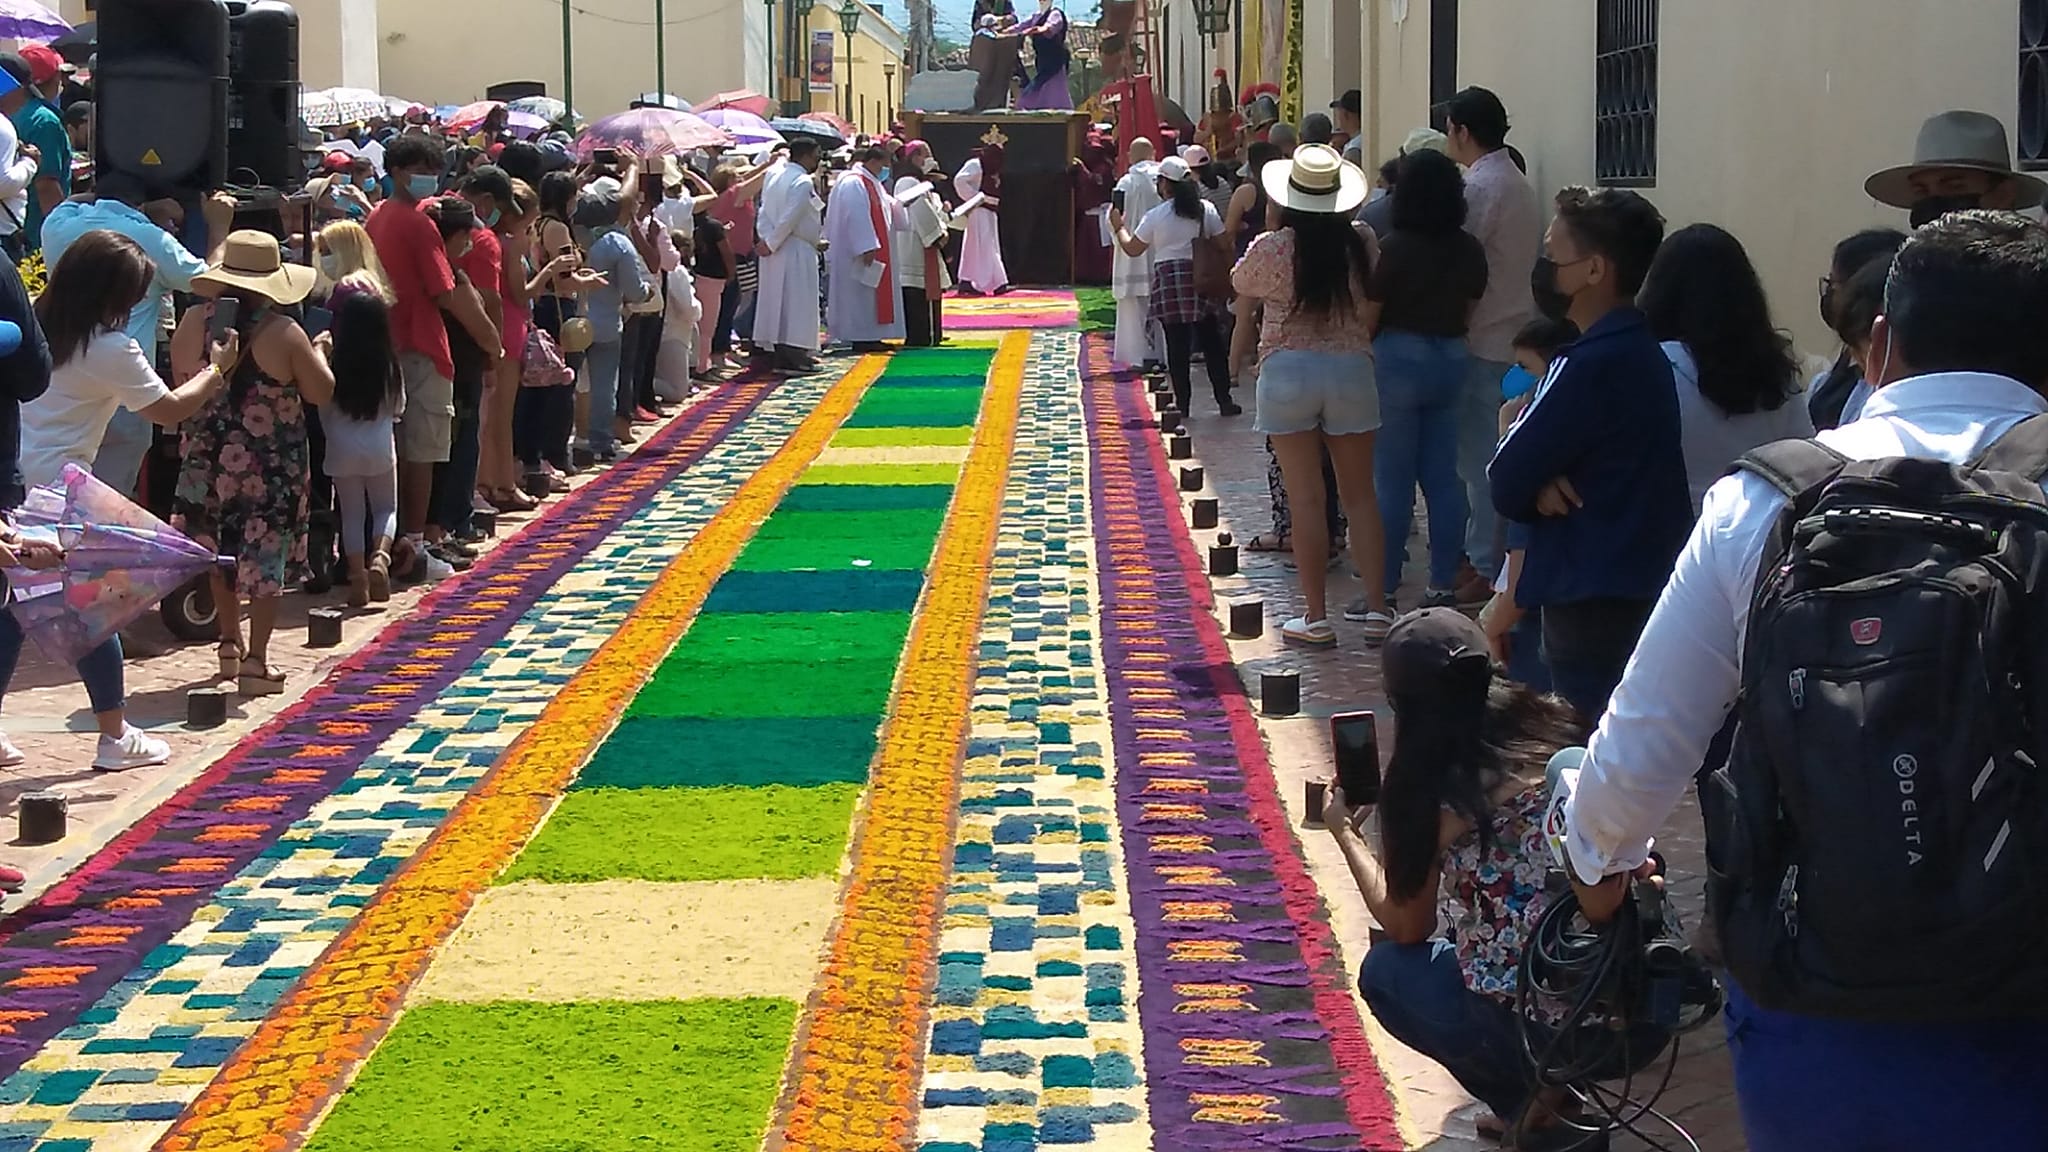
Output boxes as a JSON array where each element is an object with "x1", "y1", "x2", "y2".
[{"x1": 512, "y1": 778, "x2": 862, "y2": 877}]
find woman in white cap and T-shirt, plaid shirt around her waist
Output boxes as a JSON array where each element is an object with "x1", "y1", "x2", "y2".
[{"x1": 1110, "y1": 156, "x2": 1243, "y2": 416}]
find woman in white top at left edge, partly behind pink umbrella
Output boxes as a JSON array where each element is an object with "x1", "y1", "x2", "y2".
[{"x1": 0, "y1": 232, "x2": 240, "y2": 771}]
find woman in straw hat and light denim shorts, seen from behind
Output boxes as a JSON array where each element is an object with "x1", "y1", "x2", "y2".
[{"x1": 1231, "y1": 143, "x2": 1393, "y2": 648}]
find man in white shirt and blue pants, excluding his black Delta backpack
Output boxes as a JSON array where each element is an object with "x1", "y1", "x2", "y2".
[{"x1": 1565, "y1": 211, "x2": 2048, "y2": 1152}]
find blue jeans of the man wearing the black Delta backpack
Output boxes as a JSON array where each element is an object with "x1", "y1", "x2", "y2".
[{"x1": 1728, "y1": 975, "x2": 2048, "y2": 1152}]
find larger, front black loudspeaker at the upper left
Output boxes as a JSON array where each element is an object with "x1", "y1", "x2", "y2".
[{"x1": 92, "y1": 0, "x2": 229, "y2": 199}]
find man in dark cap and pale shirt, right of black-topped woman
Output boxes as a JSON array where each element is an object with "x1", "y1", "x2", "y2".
[{"x1": 1441, "y1": 88, "x2": 1544, "y2": 605}]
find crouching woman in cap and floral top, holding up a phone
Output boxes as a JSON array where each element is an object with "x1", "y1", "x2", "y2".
[{"x1": 1323, "y1": 609, "x2": 1606, "y2": 1150}]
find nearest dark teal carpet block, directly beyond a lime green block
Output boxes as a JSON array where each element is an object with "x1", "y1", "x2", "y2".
[{"x1": 573, "y1": 715, "x2": 879, "y2": 789}]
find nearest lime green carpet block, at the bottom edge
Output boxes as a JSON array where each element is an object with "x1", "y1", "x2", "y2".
[{"x1": 305, "y1": 998, "x2": 797, "y2": 1152}]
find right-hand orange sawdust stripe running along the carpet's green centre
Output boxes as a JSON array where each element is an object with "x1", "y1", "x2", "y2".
[{"x1": 782, "y1": 332, "x2": 1030, "y2": 1152}]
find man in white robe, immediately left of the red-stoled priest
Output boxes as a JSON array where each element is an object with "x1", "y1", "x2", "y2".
[{"x1": 754, "y1": 135, "x2": 825, "y2": 373}]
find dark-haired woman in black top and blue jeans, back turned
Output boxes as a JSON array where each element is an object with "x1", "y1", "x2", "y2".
[{"x1": 1343, "y1": 148, "x2": 1487, "y2": 619}]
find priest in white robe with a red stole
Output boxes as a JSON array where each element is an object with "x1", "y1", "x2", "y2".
[{"x1": 825, "y1": 146, "x2": 903, "y2": 353}]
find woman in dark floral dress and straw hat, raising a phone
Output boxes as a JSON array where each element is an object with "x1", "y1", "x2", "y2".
[{"x1": 170, "y1": 230, "x2": 334, "y2": 695}]
